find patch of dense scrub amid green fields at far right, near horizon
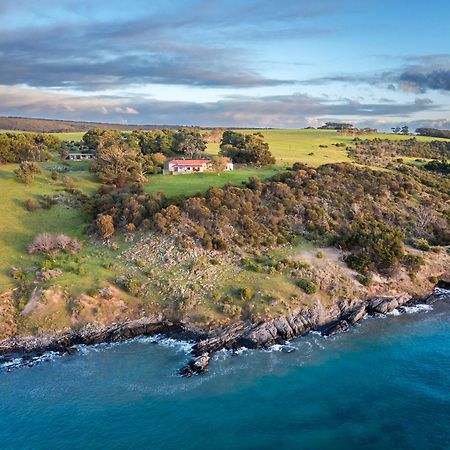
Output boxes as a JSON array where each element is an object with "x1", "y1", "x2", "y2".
[{"x1": 348, "y1": 138, "x2": 450, "y2": 166}]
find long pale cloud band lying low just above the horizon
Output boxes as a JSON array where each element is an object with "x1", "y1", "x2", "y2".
[{"x1": 0, "y1": 86, "x2": 439, "y2": 127}]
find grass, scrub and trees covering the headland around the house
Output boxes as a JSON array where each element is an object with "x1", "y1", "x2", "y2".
[{"x1": 0, "y1": 129, "x2": 450, "y2": 338}]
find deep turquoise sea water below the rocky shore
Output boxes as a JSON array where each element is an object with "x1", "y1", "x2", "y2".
[{"x1": 0, "y1": 302, "x2": 450, "y2": 449}]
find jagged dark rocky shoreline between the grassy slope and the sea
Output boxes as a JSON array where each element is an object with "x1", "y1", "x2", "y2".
[{"x1": 0, "y1": 280, "x2": 450, "y2": 376}]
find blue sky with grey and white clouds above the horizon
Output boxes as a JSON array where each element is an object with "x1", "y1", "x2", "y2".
[{"x1": 0, "y1": 0, "x2": 450, "y2": 130}]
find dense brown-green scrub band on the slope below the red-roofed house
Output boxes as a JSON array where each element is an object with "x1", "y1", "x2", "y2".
[{"x1": 90, "y1": 163, "x2": 450, "y2": 272}]
